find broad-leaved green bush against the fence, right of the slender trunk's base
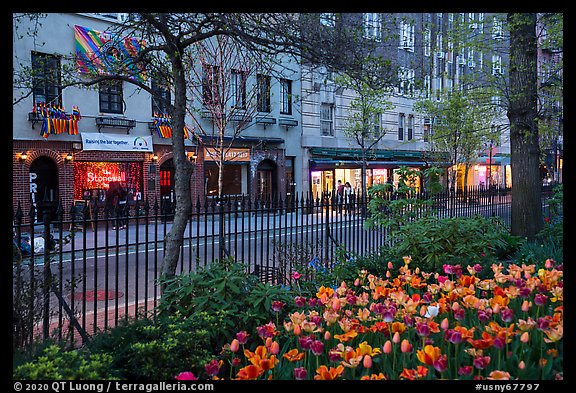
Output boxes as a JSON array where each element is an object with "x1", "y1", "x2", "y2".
[{"x1": 159, "y1": 260, "x2": 292, "y2": 344}]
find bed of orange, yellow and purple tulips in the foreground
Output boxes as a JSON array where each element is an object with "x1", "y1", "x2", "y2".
[{"x1": 183, "y1": 257, "x2": 564, "y2": 380}]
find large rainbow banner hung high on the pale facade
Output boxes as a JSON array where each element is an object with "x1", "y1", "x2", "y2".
[{"x1": 74, "y1": 25, "x2": 146, "y2": 82}]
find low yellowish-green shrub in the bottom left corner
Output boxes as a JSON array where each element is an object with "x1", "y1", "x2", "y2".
[{"x1": 12, "y1": 344, "x2": 117, "y2": 380}]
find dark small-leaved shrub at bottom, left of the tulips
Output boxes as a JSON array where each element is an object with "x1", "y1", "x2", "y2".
[{"x1": 87, "y1": 313, "x2": 218, "y2": 380}]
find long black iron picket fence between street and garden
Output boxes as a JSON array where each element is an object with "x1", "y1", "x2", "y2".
[{"x1": 13, "y1": 187, "x2": 546, "y2": 347}]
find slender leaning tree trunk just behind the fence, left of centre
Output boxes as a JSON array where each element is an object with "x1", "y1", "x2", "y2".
[{"x1": 162, "y1": 50, "x2": 192, "y2": 289}]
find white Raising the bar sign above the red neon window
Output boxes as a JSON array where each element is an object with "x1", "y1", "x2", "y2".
[{"x1": 80, "y1": 132, "x2": 154, "y2": 153}]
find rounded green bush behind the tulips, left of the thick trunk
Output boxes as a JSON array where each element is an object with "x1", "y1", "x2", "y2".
[{"x1": 387, "y1": 216, "x2": 522, "y2": 272}]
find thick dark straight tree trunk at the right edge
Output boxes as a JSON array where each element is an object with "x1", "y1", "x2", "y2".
[{"x1": 508, "y1": 13, "x2": 542, "y2": 240}]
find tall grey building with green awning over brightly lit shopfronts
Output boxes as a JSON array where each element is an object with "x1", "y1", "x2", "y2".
[{"x1": 301, "y1": 13, "x2": 511, "y2": 195}]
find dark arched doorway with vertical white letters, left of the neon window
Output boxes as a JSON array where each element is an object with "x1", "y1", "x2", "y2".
[{"x1": 29, "y1": 156, "x2": 60, "y2": 222}]
